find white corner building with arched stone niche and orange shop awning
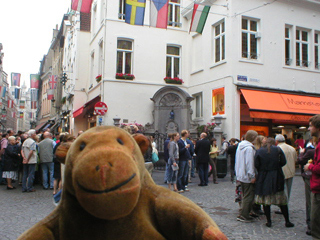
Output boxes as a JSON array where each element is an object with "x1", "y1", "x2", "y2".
[{"x1": 64, "y1": 0, "x2": 320, "y2": 142}]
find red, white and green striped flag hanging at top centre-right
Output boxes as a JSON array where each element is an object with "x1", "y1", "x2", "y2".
[{"x1": 190, "y1": 4, "x2": 210, "y2": 34}]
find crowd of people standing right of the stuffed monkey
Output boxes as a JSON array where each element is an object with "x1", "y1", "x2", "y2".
[{"x1": 164, "y1": 115, "x2": 320, "y2": 239}]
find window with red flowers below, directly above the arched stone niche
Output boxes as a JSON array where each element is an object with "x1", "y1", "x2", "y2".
[{"x1": 166, "y1": 46, "x2": 180, "y2": 78}]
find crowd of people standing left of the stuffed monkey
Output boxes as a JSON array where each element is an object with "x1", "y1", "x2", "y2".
[{"x1": 0, "y1": 129, "x2": 81, "y2": 202}]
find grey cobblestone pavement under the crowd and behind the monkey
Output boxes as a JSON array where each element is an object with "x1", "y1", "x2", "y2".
[{"x1": 0, "y1": 171, "x2": 311, "y2": 240}]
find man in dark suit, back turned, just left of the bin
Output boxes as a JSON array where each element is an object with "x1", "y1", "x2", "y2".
[{"x1": 194, "y1": 133, "x2": 210, "y2": 186}]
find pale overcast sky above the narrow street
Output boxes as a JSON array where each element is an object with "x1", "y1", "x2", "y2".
[{"x1": 0, "y1": 0, "x2": 71, "y2": 87}]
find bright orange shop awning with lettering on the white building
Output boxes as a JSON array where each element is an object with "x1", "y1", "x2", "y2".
[{"x1": 240, "y1": 89, "x2": 320, "y2": 122}]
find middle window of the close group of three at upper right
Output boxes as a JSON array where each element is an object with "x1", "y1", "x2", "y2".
[{"x1": 296, "y1": 29, "x2": 310, "y2": 67}]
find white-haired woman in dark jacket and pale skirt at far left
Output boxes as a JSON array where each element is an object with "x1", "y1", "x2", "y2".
[{"x1": 2, "y1": 136, "x2": 20, "y2": 190}]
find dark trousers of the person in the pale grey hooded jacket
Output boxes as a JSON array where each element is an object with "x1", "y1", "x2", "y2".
[{"x1": 240, "y1": 182, "x2": 254, "y2": 219}]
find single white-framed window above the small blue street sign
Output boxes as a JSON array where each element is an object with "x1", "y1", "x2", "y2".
[{"x1": 241, "y1": 18, "x2": 260, "y2": 59}]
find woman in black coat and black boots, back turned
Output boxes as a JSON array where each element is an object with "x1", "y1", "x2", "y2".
[{"x1": 255, "y1": 138, "x2": 294, "y2": 227}]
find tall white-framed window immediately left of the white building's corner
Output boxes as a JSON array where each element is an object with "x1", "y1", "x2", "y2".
[{"x1": 213, "y1": 21, "x2": 225, "y2": 62}]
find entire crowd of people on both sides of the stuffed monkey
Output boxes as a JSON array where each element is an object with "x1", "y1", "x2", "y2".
[{"x1": 0, "y1": 118, "x2": 320, "y2": 239}]
